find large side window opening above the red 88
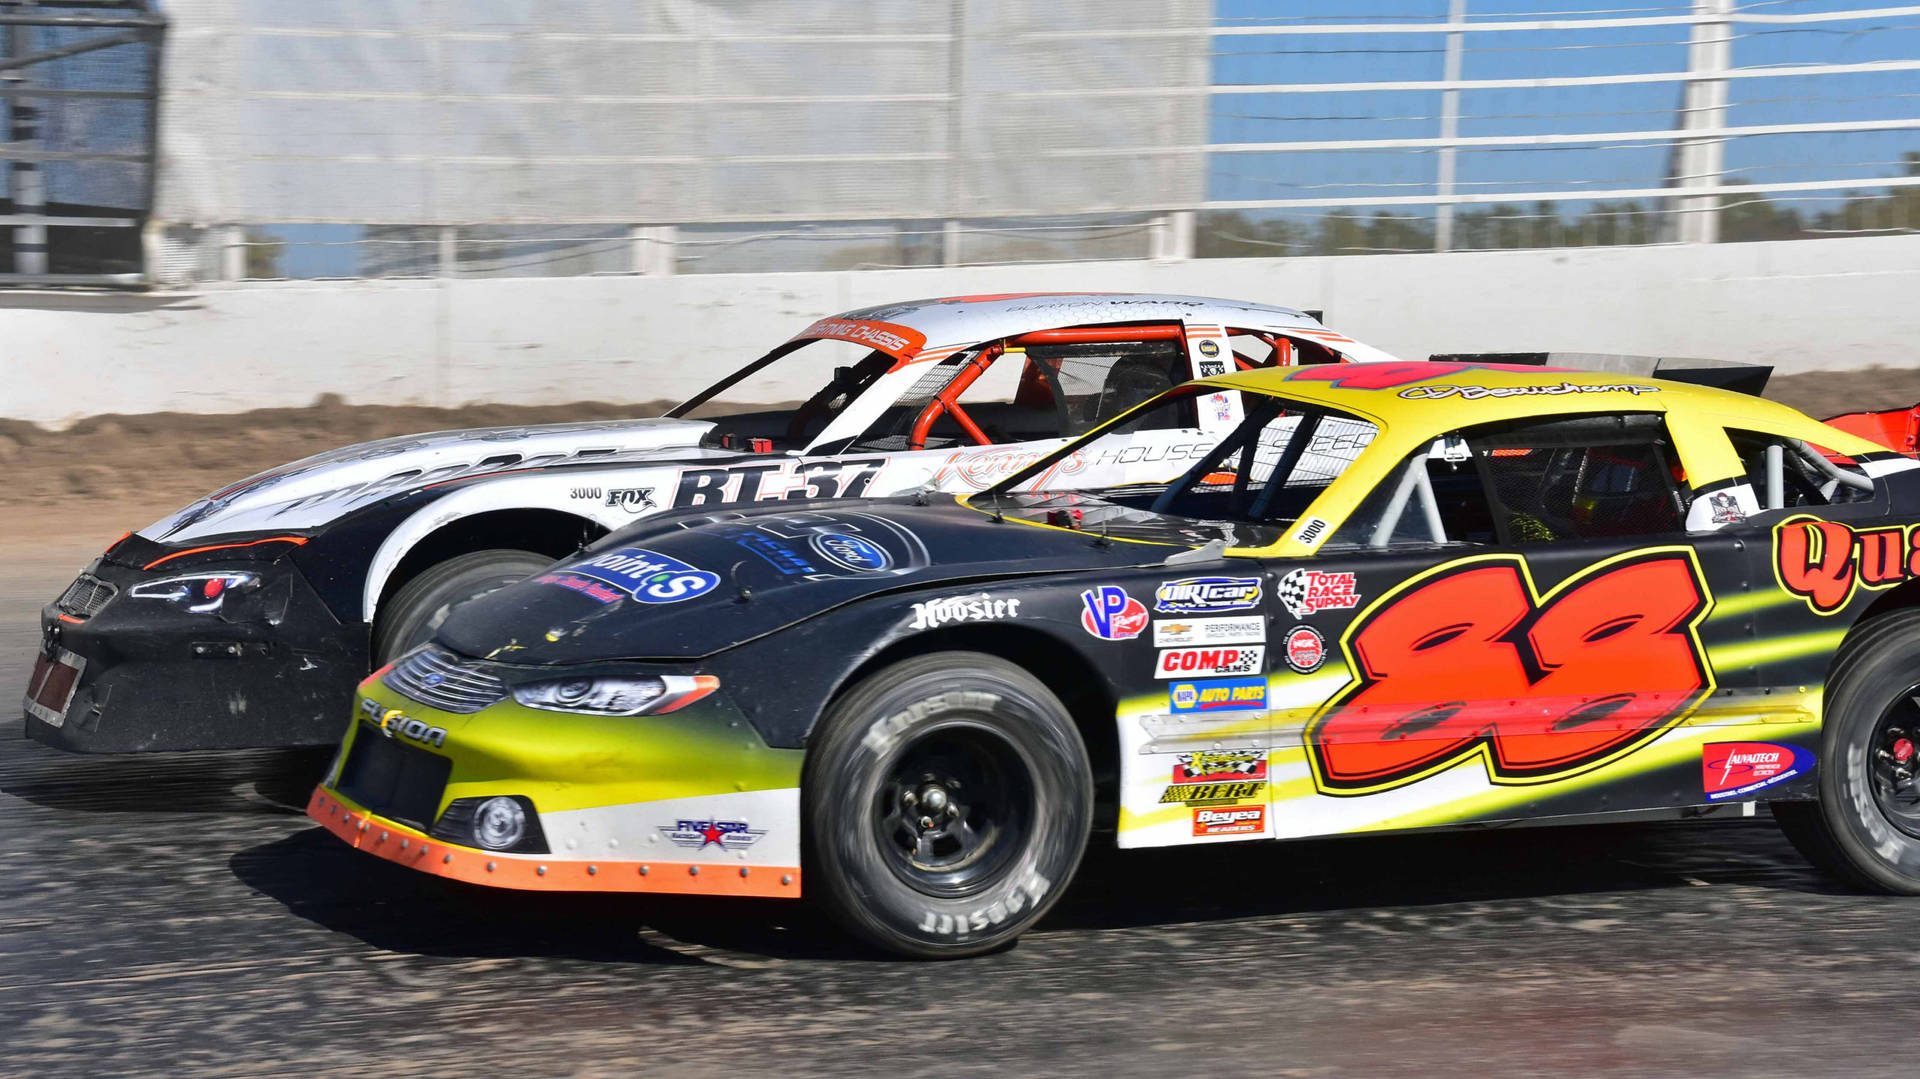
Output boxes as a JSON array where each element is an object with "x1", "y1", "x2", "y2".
[{"x1": 1334, "y1": 413, "x2": 1693, "y2": 547}]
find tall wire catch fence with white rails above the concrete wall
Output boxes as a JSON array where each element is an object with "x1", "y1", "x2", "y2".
[{"x1": 33, "y1": 0, "x2": 1920, "y2": 284}]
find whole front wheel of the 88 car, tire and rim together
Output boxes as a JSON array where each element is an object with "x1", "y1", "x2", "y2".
[{"x1": 803, "y1": 653, "x2": 1092, "y2": 958}]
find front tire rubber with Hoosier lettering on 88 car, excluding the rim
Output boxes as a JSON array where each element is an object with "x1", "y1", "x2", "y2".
[{"x1": 804, "y1": 653, "x2": 1092, "y2": 958}]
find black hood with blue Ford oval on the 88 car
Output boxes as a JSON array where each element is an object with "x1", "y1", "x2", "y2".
[{"x1": 438, "y1": 497, "x2": 1192, "y2": 664}]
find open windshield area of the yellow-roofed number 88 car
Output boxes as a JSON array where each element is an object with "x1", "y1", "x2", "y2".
[{"x1": 973, "y1": 386, "x2": 1379, "y2": 530}]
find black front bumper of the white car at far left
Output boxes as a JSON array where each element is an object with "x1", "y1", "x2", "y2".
[{"x1": 21, "y1": 545, "x2": 369, "y2": 753}]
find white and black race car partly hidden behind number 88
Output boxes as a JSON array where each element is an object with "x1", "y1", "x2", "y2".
[{"x1": 25, "y1": 294, "x2": 1392, "y2": 753}]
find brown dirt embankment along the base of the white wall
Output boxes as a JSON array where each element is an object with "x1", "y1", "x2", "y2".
[{"x1": 0, "y1": 367, "x2": 1920, "y2": 553}]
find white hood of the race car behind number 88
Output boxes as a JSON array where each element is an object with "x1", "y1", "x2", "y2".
[{"x1": 140, "y1": 419, "x2": 712, "y2": 543}]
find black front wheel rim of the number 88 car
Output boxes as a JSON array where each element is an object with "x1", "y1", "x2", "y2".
[{"x1": 872, "y1": 722, "x2": 1035, "y2": 899}]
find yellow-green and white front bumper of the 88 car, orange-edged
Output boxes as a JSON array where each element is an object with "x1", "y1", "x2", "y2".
[{"x1": 307, "y1": 670, "x2": 803, "y2": 899}]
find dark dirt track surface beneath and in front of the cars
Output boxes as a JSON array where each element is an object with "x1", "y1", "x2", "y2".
[{"x1": 0, "y1": 549, "x2": 1920, "y2": 1079}]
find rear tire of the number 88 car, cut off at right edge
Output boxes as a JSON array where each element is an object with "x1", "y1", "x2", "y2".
[{"x1": 1772, "y1": 611, "x2": 1920, "y2": 895}]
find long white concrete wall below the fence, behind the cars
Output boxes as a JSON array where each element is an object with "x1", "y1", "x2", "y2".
[{"x1": 0, "y1": 236, "x2": 1920, "y2": 424}]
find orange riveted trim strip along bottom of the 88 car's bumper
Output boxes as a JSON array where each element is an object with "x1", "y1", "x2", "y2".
[{"x1": 307, "y1": 787, "x2": 801, "y2": 899}]
